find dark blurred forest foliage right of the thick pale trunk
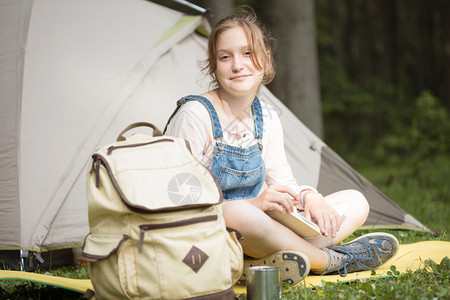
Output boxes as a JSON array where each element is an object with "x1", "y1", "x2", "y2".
[{"x1": 316, "y1": 0, "x2": 450, "y2": 172}]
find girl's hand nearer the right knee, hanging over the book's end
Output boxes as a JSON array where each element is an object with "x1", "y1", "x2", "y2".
[{"x1": 303, "y1": 191, "x2": 341, "y2": 238}]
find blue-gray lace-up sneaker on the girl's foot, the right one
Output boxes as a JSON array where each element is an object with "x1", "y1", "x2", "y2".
[{"x1": 324, "y1": 232, "x2": 399, "y2": 277}]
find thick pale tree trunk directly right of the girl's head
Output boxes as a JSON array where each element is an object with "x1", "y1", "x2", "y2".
[{"x1": 256, "y1": 0, "x2": 323, "y2": 138}]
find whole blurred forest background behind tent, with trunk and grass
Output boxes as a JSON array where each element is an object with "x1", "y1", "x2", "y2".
[{"x1": 171, "y1": 0, "x2": 450, "y2": 236}]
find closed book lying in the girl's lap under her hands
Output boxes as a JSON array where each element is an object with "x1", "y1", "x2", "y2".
[{"x1": 266, "y1": 210, "x2": 322, "y2": 239}]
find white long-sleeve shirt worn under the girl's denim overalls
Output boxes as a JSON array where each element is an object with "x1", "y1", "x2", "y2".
[{"x1": 166, "y1": 101, "x2": 315, "y2": 193}]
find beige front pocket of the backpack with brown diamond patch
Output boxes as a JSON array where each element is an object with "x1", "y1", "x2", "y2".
[{"x1": 136, "y1": 215, "x2": 233, "y2": 299}]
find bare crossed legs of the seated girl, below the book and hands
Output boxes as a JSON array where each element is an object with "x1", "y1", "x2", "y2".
[{"x1": 223, "y1": 190, "x2": 368, "y2": 269}]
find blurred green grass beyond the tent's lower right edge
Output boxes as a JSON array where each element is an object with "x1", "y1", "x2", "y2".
[{"x1": 353, "y1": 154, "x2": 450, "y2": 239}]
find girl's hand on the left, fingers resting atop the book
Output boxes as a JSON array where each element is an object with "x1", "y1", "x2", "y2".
[{"x1": 248, "y1": 185, "x2": 299, "y2": 214}]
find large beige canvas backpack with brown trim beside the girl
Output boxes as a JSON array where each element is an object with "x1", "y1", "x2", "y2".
[{"x1": 83, "y1": 123, "x2": 243, "y2": 299}]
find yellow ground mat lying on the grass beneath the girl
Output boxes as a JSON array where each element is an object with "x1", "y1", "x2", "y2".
[{"x1": 0, "y1": 241, "x2": 450, "y2": 294}]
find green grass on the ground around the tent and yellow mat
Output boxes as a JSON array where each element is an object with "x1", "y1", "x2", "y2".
[{"x1": 0, "y1": 156, "x2": 450, "y2": 300}]
